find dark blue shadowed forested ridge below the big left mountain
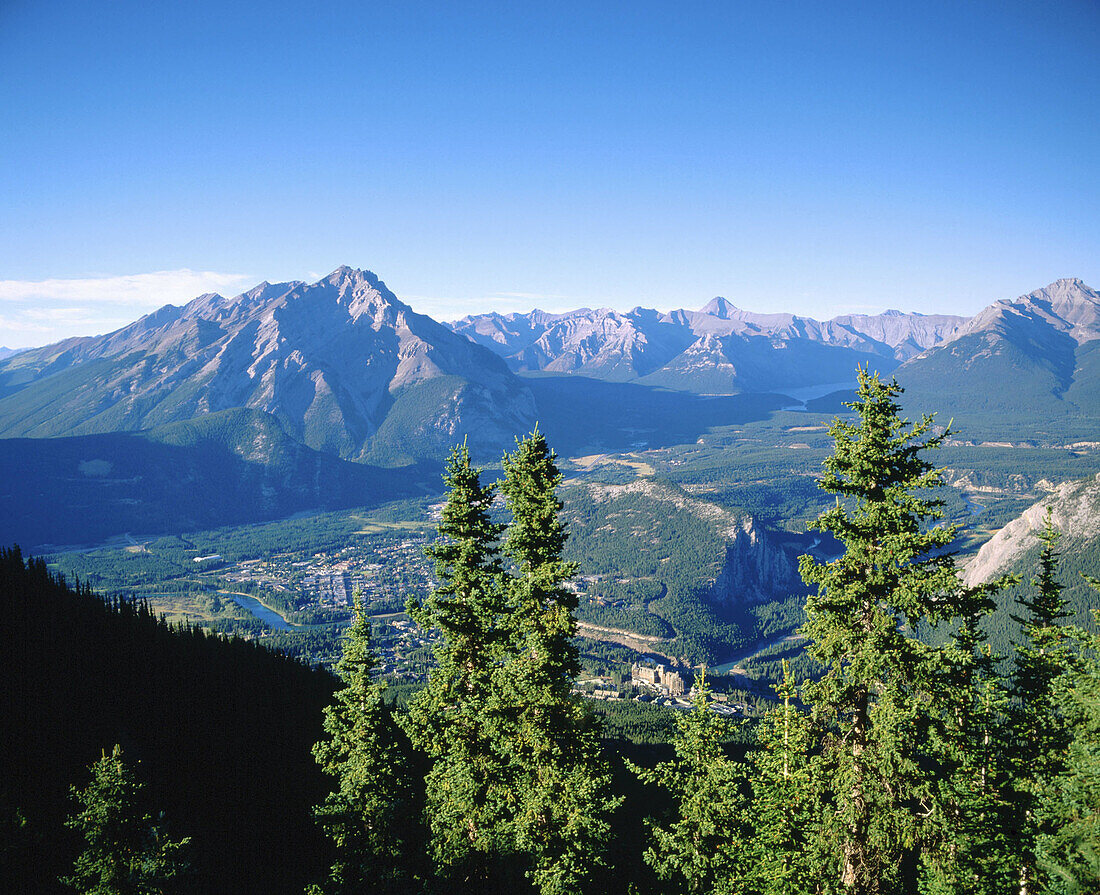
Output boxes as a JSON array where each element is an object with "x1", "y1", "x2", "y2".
[{"x1": 0, "y1": 408, "x2": 439, "y2": 546}]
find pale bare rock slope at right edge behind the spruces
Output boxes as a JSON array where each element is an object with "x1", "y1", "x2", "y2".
[{"x1": 964, "y1": 476, "x2": 1100, "y2": 587}]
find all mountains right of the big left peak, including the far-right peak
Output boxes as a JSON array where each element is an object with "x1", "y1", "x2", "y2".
[{"x1": 451, "y1": 279, "x2": 1100, "y2": 427}]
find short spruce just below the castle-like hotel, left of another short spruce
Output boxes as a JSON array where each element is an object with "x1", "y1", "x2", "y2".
[{"x1": 628, "y1": 677, "x2": 751, "y2": 895}]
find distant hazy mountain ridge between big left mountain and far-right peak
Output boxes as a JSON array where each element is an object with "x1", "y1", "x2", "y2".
[{"x1": 450, "y1": 297, "x2": 967, "y2": 394}]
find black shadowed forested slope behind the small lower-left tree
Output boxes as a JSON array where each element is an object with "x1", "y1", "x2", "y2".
[{"x1": 0, "y1": 549, "x2": 333, "y2": 895}]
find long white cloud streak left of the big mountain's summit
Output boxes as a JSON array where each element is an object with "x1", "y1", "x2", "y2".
[{"x1": 0, "y1": 267, "x2": 253, "y2": 308}]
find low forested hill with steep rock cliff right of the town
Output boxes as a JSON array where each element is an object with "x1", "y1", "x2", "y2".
[{"x1": 562, "y1": 477, "x2": 813, "y2": 665}]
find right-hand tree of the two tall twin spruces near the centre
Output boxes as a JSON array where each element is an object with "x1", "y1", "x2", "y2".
[{"x1": 496, "y1": 428, "x2": 618, "y2": 895}]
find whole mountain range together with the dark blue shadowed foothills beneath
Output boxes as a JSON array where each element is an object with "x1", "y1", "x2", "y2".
[{"x1": 0, "y1": 267, "x2": 1100, "y2": 542}]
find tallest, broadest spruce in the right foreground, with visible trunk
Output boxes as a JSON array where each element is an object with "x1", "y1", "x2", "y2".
[{"x1": 800, "y1": 369, "x2": 991, "y2": 895}]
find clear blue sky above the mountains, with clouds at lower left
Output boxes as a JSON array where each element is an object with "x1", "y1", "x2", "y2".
[{"x1": 0, "y1": 0, "x2": 1100, "y2": 346}]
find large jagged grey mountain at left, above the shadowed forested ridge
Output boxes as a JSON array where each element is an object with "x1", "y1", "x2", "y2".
[{"x1": 0, "y1": 267, "x2": 534, "y2": 458}]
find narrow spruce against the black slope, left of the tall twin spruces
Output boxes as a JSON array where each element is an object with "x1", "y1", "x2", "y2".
[{"x1": 309, "y1": 590, "x2": 420, "y2": 895}]
